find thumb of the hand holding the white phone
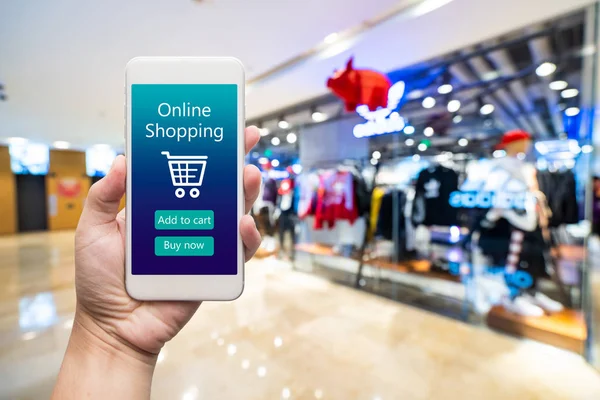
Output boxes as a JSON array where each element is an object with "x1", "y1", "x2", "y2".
[{"x1": 80, "y1": 156, "x2": 127, "y2": 226}]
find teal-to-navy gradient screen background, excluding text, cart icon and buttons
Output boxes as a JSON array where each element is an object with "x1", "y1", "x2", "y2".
[{"x1": 128, "y1": 84, "x2": 238, "y2": 275}]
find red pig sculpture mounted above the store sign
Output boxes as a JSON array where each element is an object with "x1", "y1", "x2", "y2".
[{"x1": 327, "y1": 57, "x2": 392, "y2": 111}]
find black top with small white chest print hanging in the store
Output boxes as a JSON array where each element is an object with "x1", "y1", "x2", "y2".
[{"x1": 413, "y1": 165, "x2": 459, "y2": 226}]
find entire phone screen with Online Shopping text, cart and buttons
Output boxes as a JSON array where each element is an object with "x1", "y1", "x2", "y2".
[{"x1": 132, "y1": 84, "x2": 238, "y2": 275}]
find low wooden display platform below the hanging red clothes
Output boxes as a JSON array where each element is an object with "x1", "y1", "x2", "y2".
[{"x1": 296, "y1": 243, "x2": 460, "y2": 282}]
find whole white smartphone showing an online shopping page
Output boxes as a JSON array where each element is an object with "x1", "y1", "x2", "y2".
[{"x1": 125, "y1": 57, "x2": 245, "y2": 300}]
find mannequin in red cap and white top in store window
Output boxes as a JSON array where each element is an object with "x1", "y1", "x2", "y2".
[{"x1": 480, "y1": 131, "x2": 563, "y2": 317}]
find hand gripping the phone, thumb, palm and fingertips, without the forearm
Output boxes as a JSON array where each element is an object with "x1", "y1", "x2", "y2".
[{"x1": 74, "y1": 127, "x2": 261, "y2": 363}]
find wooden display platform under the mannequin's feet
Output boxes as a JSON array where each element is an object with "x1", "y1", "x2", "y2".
[{"x1": 487, "y1": 306, "x2": 587, "y2": 354}]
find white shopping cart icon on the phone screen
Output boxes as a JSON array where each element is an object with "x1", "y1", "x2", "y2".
[{"x1": 160, "y1": 151, "x2": 208, "y2": 199}]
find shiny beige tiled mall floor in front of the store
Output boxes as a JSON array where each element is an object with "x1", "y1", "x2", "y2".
[{"x1": 0, "y1": 232, "x2": 600, "y2": 400}]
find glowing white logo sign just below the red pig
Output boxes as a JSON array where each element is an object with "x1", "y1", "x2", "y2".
[{"x1": 352, "y1": 81, "x2": 406, "y2": 138}]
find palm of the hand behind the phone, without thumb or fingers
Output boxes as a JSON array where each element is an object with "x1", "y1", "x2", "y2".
[{"x1": 75, "y1": 208, "x2": 200, "y2": 353}]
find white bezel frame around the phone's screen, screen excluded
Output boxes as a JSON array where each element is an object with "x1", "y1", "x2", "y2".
[{"x1": 125, "y1": 57, "x2": 245, "y2": 300}]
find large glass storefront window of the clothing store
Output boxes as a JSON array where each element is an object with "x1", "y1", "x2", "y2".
[{"x1": 251, "y1": 7, "x2": 600, "y2": 359}]
